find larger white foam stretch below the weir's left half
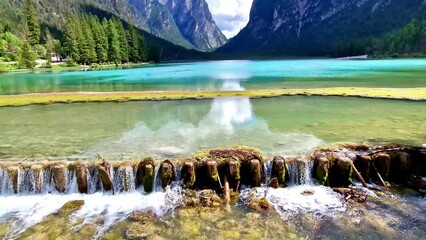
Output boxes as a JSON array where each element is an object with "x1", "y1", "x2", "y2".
[{"x1": 0, "y1": 188, "x2": 181, "y2": 238}]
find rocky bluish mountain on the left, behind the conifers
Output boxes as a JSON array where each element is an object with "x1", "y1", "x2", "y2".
[{"x1": 0, "y1": 0, "x2": 227, "y2": 51}]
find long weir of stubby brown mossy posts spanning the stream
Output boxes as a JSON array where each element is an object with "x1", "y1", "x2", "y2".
[{"x1": 0, "y1": 144, "x2": 426, "y2": 195}]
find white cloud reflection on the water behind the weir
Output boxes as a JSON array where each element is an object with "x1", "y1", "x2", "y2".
[{"x1": 84, "y1": 79, "x2": 323, "y2": 158}]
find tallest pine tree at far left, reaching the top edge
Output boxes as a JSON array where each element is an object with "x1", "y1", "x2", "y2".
[{"x1": 24, "y1": 0, "x2": 40, "y2": 46}]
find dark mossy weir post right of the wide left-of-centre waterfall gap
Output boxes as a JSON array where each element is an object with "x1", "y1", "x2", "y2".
[{"x1": 136, "y1": 158, "x2": 155, "y2": 193}]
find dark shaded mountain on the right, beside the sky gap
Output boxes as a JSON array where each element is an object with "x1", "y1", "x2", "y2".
[{"x1": 217, "y1": 0, "x2": 426, "y2": 56}]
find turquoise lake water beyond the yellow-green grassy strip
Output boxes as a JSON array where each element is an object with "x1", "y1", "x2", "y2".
[{"x1": 0, "y1": 60, "x2": 426, "y2": 94}]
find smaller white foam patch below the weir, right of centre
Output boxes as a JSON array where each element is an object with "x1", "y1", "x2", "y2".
[{"x1": 242, "y1": 185, "x2": 346, "y2": 219}]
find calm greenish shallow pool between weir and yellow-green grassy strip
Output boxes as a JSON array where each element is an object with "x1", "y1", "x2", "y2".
[{"x1": 0, "y1": 96, "x2": 426, "y2": 159}]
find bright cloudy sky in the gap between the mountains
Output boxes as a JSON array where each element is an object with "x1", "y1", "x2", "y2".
[{"x1": 207, "y1": 0, "x2": 253, "y2": 38}]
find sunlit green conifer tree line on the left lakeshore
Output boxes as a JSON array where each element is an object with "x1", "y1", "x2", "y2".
[{"x1": 0, "y1": 0, "x2": 160, "y2": 68}]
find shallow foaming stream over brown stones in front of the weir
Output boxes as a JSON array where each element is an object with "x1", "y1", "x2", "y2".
[{"x1": 0, "y1": 185, "x2": 426, "y2": 239}]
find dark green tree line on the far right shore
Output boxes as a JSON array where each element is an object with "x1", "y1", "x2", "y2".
[{"x1": 334, "y1": 20, "x2": 426, "y2": 57}]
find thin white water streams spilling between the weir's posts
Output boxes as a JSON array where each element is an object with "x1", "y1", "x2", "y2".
[{"x1": 0, "y1": 157, "x2": 320, "y2": 195}]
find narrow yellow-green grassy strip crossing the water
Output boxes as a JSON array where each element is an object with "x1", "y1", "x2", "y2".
[{"x1": 0, "y1": 88, "x2": 426, "y2": 107}]
